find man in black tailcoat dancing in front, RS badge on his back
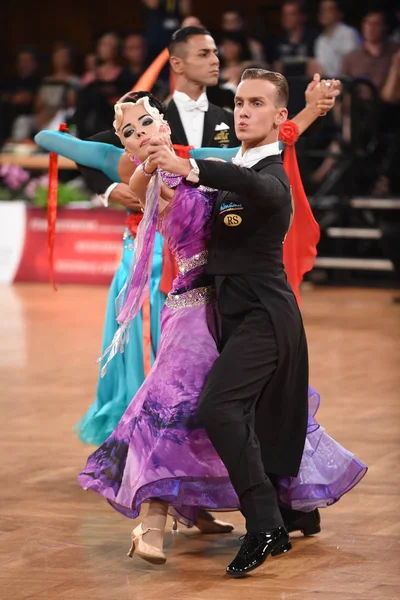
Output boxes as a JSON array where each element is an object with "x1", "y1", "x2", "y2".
[{"x1": 149, "y1": 69, "x2": 312, "y2": 577}]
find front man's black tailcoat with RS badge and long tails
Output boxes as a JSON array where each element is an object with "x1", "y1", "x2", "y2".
[{"x1": 197, "y1": 155, "x2": 308, "y2": 476}]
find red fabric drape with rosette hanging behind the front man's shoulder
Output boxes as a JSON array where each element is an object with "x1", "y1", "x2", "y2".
[{"x1": 279, "y1": 121, "x2": 320, "y2": 303}]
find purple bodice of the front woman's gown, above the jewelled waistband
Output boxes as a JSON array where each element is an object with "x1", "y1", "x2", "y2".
[{"x1": 158, "y1": 183, "x2": 217, "y2": 290}]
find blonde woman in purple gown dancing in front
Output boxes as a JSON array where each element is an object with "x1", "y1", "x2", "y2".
[{"x1": 79, "y1": 92, "x2": 366, "y2": 564}]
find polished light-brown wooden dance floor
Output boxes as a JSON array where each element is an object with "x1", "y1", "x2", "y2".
[{"x1": 0, "y1": 285, "x2": 400, "y2": 600}]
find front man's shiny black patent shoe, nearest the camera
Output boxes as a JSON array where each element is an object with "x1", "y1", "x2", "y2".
[{"x1": 226, "y1": 527, "x2": 292, "y2": 577}]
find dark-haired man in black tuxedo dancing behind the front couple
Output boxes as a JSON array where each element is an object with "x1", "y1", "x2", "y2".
[{"x1": 79, "y1": 27, "x2": 239, "y2": 210}]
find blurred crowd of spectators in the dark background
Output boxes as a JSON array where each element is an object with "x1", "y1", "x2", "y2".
[{"x1": 0, "y1": 0, "x2": 400, "y2": 204}]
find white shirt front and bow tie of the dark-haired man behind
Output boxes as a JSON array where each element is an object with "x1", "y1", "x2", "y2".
[{"x1": 172, "y1": 91, "x2": 208, "y2": 148}]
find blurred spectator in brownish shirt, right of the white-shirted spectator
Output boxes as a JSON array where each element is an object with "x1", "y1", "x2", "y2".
[{"x1": 341, "y1": 10, "x2": 400, "y2": 91}]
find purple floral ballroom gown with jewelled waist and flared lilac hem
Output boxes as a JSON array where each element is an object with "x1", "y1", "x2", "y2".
[{"x1": 79, "y1": 175, "x2": 366, "y2": 525}]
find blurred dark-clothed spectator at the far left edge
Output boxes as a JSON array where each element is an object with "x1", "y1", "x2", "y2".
[{"x1": 0, "y1": 48, "x2": 40, "y2": 146}]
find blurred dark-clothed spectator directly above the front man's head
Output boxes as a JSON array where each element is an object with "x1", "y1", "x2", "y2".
[{"x1": 271, "y1": 0, "x2": 318, "y2": 77}]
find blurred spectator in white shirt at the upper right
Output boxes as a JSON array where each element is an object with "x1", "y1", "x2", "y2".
[{"x1": 315, "y1": 0, "x2": 361, "y2": 77}]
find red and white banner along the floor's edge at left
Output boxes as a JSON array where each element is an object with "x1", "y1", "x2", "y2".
[{"x1": 0, "y1": 202, "x2": 126, "y2": 285}]
